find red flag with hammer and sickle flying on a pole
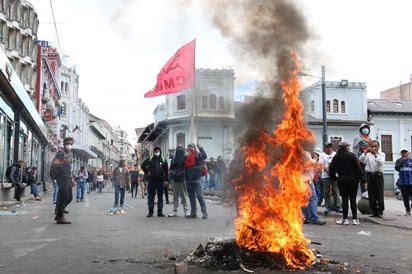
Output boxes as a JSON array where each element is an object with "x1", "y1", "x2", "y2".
[{"x1": 144, "y1": 40, "x2": 196, "y2": 98}]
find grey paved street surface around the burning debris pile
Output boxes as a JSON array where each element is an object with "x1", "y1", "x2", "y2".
[{"x1": 0, "y1": 188, "x2": 412, "y2": 274}]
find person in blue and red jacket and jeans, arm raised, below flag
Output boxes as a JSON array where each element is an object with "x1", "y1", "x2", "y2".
[{"x1": 184, "y1": 144, "x2": 208, "y2": 219}]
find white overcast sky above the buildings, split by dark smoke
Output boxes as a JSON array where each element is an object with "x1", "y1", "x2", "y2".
[{"x1": 30, "y1": 0, "x2": 412, "y2": 142}]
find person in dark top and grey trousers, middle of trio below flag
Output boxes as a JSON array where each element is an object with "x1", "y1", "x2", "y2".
[{"x1": 168, "y1": 145, "x2": 189, "y2": 217}]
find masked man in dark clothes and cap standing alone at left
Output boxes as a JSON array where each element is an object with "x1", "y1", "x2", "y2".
[{"x1": 52, "y1": 137, "x2": 76, "y2": 224}]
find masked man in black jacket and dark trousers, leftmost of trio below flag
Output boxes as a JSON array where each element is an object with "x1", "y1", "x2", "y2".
[{"x1": 142, "y1": 147, "x2": 169, "y2": 217}]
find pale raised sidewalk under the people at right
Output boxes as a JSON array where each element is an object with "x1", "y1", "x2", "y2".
[{"x1": 319, "y1": 196, "x2": 412, "y2": 230}]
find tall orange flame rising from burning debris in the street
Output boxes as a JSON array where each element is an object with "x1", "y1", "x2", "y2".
[{"x1": 235, "y1": 53, "x2": 315, "y2": 269}]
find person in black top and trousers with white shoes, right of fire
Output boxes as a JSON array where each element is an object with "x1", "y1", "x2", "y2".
[{"x1": 328, "y1": 142, "x2": 363, "y2": 225}]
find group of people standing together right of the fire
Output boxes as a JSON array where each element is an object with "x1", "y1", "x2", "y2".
[{"x1": 304, "y1": 124, "x2": 412, "y2": 225}]
